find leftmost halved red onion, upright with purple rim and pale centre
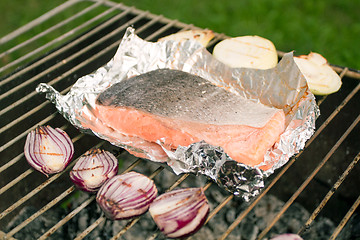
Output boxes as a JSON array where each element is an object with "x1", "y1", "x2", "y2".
[{"x1": 24, "y1": 126, "x2": 74, "y2": 176}]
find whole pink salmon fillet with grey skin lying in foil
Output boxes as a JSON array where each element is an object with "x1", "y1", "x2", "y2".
[{"x1": 84, "y1": 69, "x2": 285, "y2": 166}]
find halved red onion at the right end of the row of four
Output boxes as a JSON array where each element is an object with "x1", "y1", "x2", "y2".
[{"x1": 149, "y1": 188, "x2": 210, "y2": 238}]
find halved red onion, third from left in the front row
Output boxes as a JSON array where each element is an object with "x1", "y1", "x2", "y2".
[{"x1": 96, "y1": 172, "x2": 157, "y2": 220}]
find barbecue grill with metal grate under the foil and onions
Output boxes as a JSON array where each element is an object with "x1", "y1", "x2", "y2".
[{"x1": 0, "y1": 0, "x2": 360, "y2": 239}]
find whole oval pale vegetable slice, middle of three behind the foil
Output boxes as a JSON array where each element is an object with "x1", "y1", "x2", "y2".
[{"x1": 213, "y1": 36, "x2": 278, "y2": 69}]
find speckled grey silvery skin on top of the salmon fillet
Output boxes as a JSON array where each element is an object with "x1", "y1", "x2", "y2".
[{"x1": 97, "y1": 69, "x2": 277, "y2": 127}]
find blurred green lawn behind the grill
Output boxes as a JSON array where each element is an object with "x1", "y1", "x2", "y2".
[{"x1": 0, "y1": 0, "x2": 360, "y2": 69}]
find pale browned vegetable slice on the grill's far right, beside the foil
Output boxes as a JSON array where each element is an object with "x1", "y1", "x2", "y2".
[{"x1": 294, "y1": 52, "x2": 342, "y2": 95}]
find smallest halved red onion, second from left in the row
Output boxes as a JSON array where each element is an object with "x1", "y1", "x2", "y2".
[{"x1": 70, "y1": 149, "x2": 118, "y2": 192}]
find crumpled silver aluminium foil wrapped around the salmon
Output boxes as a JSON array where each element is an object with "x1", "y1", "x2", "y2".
[{"x1": 36, "y1": 27, "x2": 320, "y2": 200}]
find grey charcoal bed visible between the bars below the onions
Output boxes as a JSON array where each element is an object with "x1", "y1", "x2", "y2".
[{"x1": 7, "y1": 161, "x2": 344, "y2": 240}]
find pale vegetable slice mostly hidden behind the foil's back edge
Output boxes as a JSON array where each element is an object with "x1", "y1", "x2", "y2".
[{"x1": 158, "y1": 29, "x2": 215, "y2": 47}]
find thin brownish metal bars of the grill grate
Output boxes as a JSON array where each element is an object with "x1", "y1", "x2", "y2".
[{"x1": 0, "y1": 0, "x2": 360, "y2": 239}]
